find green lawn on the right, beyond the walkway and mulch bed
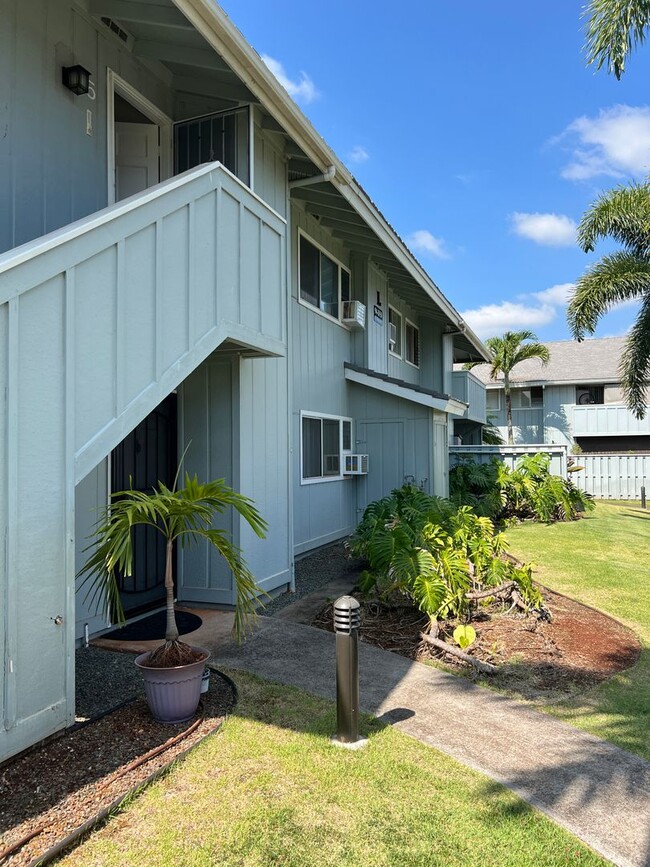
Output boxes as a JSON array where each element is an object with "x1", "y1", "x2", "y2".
[{"x1": 508, "y1": 501, "x2": 650, "y2": 758}]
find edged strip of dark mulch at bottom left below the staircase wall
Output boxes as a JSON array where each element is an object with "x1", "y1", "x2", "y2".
[{"x1": 0, "y1": 668, "x2": 236, "y2": 867}]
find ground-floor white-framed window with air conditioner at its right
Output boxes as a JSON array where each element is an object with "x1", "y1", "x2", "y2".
[{"x1": 300, "y1": 412, "x2": 352, "y2": 485}]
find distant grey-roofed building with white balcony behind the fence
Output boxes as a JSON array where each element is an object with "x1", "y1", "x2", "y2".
[{"x1": 454, "y1": 337, "x2": 650, "y2": 452}]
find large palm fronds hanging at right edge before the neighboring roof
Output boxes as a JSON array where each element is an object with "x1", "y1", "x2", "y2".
[{"x1": 567, "y1": 183, "x2": 650, "y2": 419}]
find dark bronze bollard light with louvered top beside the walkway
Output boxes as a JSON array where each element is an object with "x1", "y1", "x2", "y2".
[{"x1": 332, "y1": 596, "x2": 366, "y2": 749}]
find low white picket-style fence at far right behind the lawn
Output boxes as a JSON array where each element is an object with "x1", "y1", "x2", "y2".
[{"x1": 572, "y1": 454, "x2": 650, "y2": 500}]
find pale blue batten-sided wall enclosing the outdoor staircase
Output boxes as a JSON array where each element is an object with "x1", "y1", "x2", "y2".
[{"x1": 0, "y1": 164, "x2": 288, "y2": 758}]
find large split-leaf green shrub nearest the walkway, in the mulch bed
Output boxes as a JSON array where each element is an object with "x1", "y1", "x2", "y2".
[{"x1": 348, "y1": 485, "x2": 541, "y2": 620}]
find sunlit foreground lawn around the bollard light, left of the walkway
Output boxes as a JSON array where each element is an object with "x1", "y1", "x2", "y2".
[{"x1": 62, "y1": 673, "x2": 607, "y2": 867}]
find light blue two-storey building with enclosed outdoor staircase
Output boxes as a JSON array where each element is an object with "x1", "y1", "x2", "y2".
[{"x1": 0, "y1": 0, "x2": 487, "y2": 759}]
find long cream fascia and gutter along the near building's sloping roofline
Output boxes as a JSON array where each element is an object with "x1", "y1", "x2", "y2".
[{"x1": 173, "y1": 0, "x2": 491, "y2": 361}]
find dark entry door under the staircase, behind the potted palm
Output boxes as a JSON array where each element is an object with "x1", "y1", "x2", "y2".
[{"x1": 111, "y1": 394, "x2": 178, "y2": 615}]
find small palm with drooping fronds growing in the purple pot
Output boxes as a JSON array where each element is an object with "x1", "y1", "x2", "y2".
[{"x1": 79, "y1": 473, "x2": 267, "y2": 667}]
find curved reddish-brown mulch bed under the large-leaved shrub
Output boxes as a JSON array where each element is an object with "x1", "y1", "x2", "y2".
[{"x1": 313, "y1": 588, "x2": 641, "y2": 701}]
